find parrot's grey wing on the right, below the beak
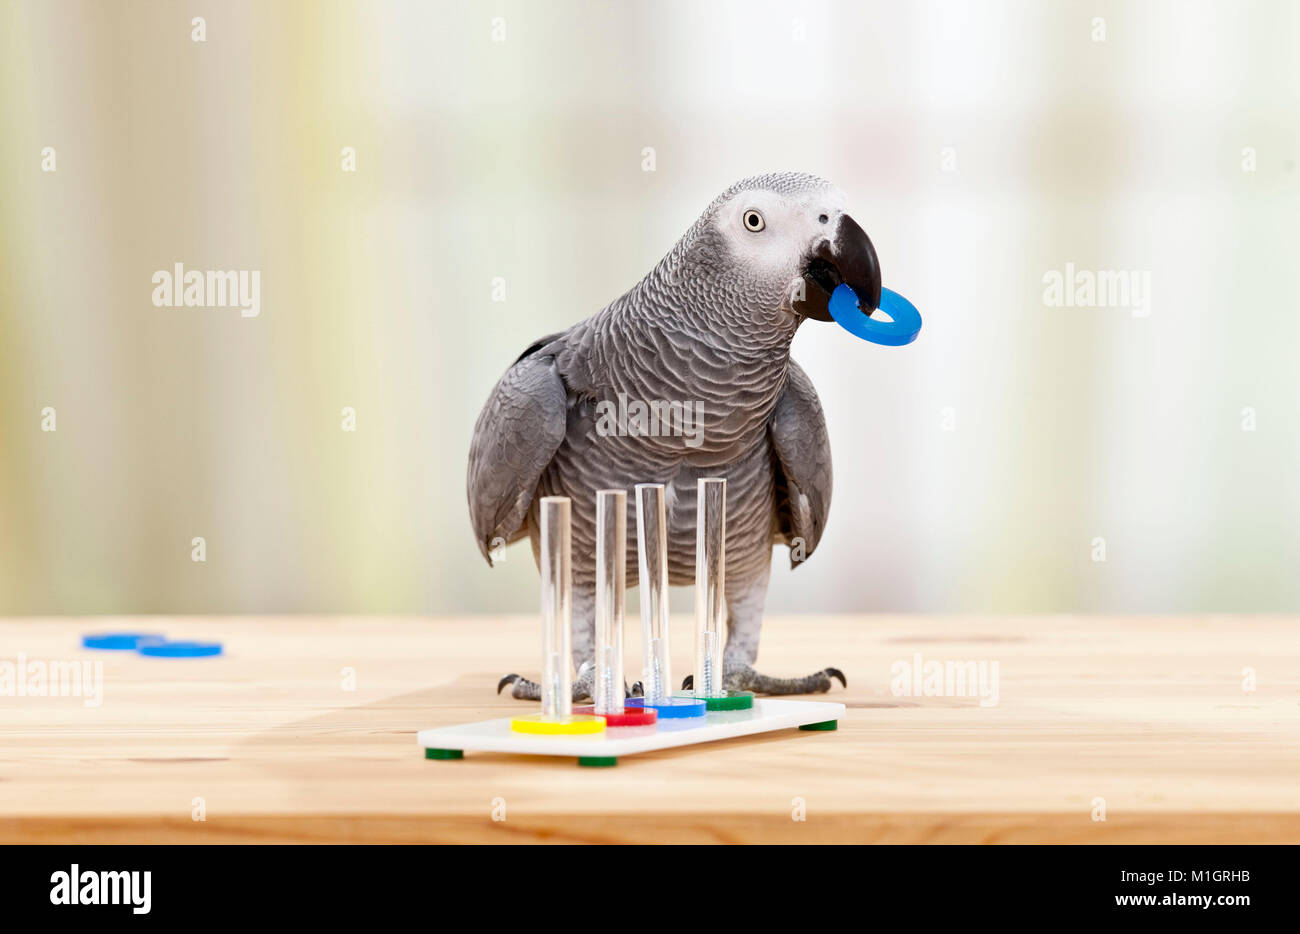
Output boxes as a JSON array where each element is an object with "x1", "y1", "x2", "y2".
[{"x1": 768, "y1": 360, "x2": 831, "y2": 566}]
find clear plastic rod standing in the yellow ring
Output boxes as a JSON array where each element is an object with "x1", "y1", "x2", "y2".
[{"x1": 541, "y1": 496, "x2": 573, "y2": 719}]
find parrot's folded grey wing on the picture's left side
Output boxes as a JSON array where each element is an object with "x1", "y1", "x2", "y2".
[{"x1": 468, "y1": 338, "x2": 568, "y2": 565}]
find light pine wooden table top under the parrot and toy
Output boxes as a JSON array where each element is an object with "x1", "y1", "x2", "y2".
[{"x1": 0, "y1": 617, "x2": 1300, "y2": 843}]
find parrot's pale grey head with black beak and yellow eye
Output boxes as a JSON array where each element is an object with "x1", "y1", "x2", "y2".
[{"x1": 688, "y1": 173, "x2": 880, "y2": 330}]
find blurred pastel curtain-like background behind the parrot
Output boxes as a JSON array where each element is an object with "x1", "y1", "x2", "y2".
[{"x1": 0, "y1": 0, "x2": 1300, "y2": 614}]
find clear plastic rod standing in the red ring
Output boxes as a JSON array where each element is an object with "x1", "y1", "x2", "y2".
[{"x1": 594, "y1": 489, "x2": 628, "y2": 713}]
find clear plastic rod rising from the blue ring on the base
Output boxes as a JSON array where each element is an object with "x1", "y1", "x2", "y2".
[{"x1": 636, "y1": 483, "x2": 672, "y2": 704}]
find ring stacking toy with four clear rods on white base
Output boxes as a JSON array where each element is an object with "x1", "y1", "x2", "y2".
[{"x1": 462, "y1": 477, "x2": 844, "y2": 767}]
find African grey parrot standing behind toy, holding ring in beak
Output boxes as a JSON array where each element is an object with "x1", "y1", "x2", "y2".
[{"x1": 468, "y1": 173, "x2": 880, "y2": 700}]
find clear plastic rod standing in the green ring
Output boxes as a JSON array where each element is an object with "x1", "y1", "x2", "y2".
[{"x1": 696, "y1": 477, "x2": 727, "y2": 697}]
